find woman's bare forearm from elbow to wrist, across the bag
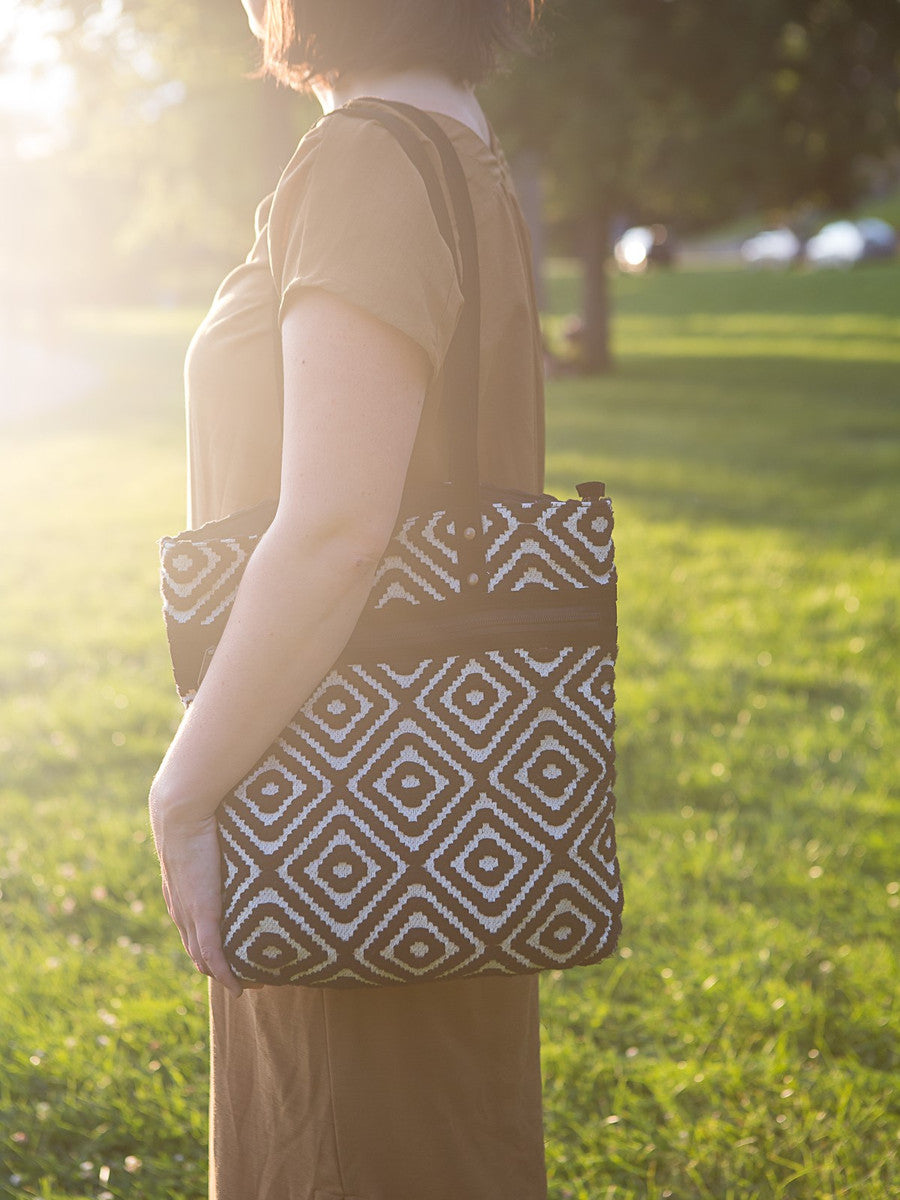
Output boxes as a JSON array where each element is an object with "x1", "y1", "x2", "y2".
[{"x1": 151, "y1": 522, "x2": 377, "y2": 820}]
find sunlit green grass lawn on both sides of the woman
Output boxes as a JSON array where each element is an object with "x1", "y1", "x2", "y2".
[{"x1": 0, "y1": 266, "x2": 900, "y2": 1200}]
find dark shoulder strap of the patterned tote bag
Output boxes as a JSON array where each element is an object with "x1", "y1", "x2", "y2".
[{"x1": 332, "y1": 98, "x2": 486, "y2": 594}]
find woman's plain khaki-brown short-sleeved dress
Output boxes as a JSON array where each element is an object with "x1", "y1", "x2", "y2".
[{"x1": 186, "y1": 103, "x2": 546, "y2": 1200}]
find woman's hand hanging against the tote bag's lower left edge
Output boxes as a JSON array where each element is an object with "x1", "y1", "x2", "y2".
[{"x1": 150, "y1": 792, "x2": 242, "y2": 997}]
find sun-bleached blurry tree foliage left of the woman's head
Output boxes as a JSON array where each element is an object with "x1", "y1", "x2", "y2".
[{"x1": 0, "y1": 0, "x2": 313, "y2": 316}]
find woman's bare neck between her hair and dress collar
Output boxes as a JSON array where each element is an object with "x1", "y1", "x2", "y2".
[{"x1": 316, "y1": 67, "x2": 491, "y2": 143}]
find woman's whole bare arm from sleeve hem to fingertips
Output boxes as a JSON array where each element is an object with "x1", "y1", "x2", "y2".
[{"x1": 150, "y1": 290, "x2": 428, "y2": 991}]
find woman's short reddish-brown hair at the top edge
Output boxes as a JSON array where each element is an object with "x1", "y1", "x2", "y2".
[{"x1": 263, "y1": 0, "x2": 541, "y2": 91}]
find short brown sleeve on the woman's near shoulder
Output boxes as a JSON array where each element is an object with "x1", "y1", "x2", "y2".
[{"x1": 268, "y1": 115, "x2": 462, "y2": 374}]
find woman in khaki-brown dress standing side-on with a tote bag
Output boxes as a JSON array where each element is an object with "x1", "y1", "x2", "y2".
[{"x1": 150, "y1": 0, "x2": 546, "y2": 1200}]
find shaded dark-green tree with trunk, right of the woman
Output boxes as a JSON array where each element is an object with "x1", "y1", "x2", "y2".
[{"x1": 490, "y1": 0, "x2": 900, "y2": 370}]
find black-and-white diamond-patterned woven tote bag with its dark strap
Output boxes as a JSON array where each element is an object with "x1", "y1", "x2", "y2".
[{"x1": 161, "y1": 101, "x2": 623, "y2": 986}]
